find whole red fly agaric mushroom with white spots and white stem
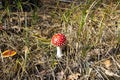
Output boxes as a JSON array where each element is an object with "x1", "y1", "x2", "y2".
[{"x1": 51, "y1": 33, "x2": 66, "y2": 58}]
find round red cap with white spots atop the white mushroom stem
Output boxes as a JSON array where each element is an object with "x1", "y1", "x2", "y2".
[{"x1": 51, "y1": 33, "x2": 66, "y2": 46}]
